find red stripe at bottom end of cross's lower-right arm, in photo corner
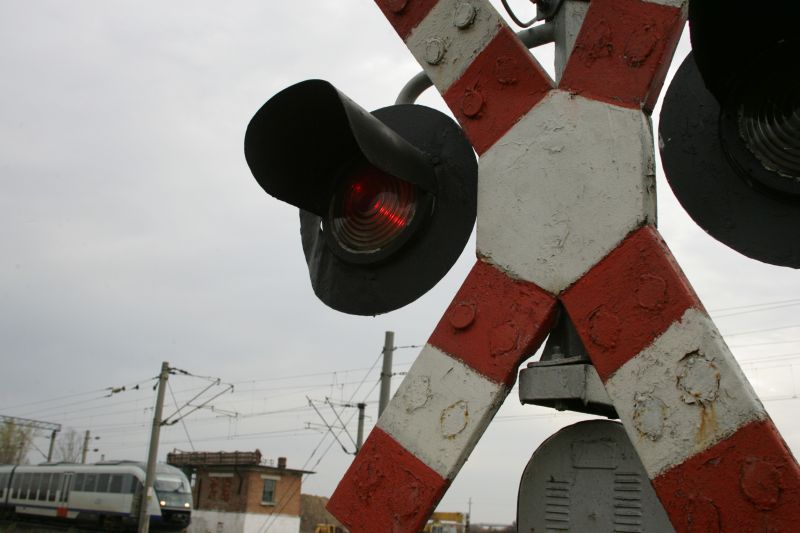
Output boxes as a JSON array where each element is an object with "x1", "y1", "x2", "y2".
[{"x1": 653, "y1": 420, "x2": 800, "y2": 533}]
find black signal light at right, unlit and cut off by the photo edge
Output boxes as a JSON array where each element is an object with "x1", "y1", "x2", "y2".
[{"x1": 659, "y1": 0, "x2": 800, "y2": 268}]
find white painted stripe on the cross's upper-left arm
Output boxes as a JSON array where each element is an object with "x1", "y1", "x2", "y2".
[{"x1": 406, "y1": 0, "x2": 502, "y2": 93}]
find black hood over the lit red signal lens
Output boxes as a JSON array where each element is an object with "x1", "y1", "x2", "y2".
[{"x1": 244, "y1": 80, "x2": 436, "y2": 216}]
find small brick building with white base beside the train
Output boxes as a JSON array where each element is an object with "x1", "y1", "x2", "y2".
[{"x1": 167, "y1": 450, "x2": 312, "y2": 533}]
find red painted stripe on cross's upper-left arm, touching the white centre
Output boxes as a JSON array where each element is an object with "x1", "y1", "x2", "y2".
[{"x1": 443, "y1": 26, "x2": 553, "y2": 154}]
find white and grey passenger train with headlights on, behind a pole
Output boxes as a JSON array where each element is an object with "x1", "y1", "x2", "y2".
[{"x1": 0, "y1": 461, "x2": 192, "y2": 531}]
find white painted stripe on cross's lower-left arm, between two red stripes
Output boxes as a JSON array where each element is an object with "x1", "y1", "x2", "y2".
[{"x1": 378, "y1": 345, "x2": 508, "y2": 479}]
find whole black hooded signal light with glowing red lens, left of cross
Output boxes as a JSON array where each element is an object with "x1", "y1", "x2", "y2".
[{"x1": 244, "y1": 80, "x2": 478, "y2": 315}]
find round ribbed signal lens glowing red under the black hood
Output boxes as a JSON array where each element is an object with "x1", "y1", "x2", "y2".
[{"x1": 330, "y1": 166, "x2": 418, "y2": 253}]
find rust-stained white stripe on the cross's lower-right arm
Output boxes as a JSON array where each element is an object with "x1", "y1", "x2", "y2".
[{"x1": 606, "y1": 309, "x2": 767, "y2": 478}]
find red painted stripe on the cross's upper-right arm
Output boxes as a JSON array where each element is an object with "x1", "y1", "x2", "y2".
[{"x1": 559, "y1": 0, "x2": 686, "y2": 110}]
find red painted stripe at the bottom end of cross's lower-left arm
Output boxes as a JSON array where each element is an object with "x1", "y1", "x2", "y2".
[{"x1": 327, "y1": 427, "x2": 449, "y2": 533}]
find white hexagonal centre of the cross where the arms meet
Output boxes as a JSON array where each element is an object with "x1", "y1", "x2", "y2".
[{"x1": 478, "y1": 91, "x2": 655, "y2": 294}]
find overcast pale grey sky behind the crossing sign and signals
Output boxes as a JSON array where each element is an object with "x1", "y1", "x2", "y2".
[{"x1": 0, "y1": 0, "x2": 800, "y2": 523}]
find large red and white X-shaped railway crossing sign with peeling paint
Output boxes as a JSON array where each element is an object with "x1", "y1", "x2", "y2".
[{"x1": 328, "y1": 0, "x2": 800, "y2": 533}]
